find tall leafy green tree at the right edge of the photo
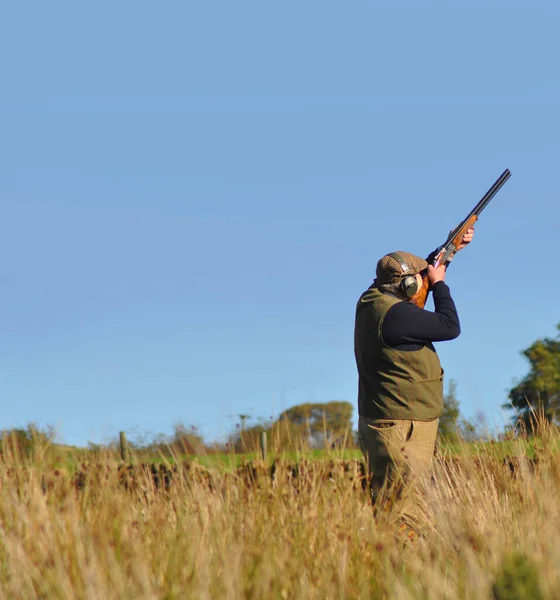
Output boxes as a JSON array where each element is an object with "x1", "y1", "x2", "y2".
[{"x1": 503, "y1": 324, "x2": 560, "y2": 429}]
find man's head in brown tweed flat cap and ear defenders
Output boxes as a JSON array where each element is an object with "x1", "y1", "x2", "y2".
[{"x1": 375, "y1": 251, "x2": 428, "y2": 300}]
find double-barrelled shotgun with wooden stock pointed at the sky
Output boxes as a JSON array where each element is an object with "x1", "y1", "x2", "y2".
[{"x1": 411, "y1": 169, "x2": 511, "y2": 308}]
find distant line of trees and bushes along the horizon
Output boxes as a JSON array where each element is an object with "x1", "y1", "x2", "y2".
[{"x1": 4, "y1": 324, "x2": 560, "y2": 459}]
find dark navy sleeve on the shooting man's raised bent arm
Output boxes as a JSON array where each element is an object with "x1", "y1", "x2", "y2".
[{"x1": 382, "y1": 281, "x2": 461, "y2": 346}]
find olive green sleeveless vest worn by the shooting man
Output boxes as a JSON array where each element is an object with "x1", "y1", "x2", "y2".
[{"x1": 354, "y1": 288, "x2": 443, "y2": 421}]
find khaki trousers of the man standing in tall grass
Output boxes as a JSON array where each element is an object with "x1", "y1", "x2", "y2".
[{"x1": 358, "y1": 417, "x2": 439, "y2": 525}]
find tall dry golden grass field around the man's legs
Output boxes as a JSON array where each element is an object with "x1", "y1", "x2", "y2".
[{"x1": 0, "y1": 428, "x2": 560, "y2": 600}]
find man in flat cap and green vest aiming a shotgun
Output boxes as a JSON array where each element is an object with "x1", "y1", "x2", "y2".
[{"x1": 354, "y1": 229, "x2": 474, "y2": 527}]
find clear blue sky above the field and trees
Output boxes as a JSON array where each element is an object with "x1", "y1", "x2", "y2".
[{"x1": 0, "y1": 0, "x2": 560, "y2": 445}]
